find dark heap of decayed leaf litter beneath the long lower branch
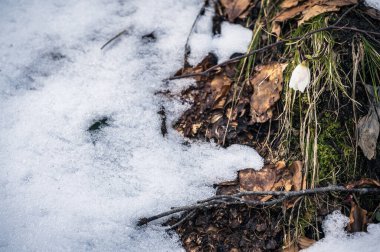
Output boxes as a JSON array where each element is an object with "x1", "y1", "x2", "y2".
[{"x1": 167, "y1": 206, "x2": 282, "y2": 252}]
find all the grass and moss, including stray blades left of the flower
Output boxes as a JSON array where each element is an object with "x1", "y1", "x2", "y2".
[{"x1": 223, "y1": 3, "x2": 380, "y2": 248}]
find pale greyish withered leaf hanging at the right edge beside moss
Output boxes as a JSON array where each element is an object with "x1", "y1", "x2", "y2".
[{"x1": 358, "y1": 108, "x2": 380, "y2": 160}]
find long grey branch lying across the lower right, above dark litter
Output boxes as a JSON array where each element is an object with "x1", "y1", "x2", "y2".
[{"x1": 137, "y1": 186, "x2": 380, "y2": 226}]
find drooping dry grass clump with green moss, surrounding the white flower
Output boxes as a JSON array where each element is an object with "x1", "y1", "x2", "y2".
[{"x1": 279, "y1": 15, "x2": 356, "y2": 246}]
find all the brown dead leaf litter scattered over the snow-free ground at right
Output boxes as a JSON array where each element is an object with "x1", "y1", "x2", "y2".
[{"x1": 162, "y1": 0, "x2": 380, "y2": 251}]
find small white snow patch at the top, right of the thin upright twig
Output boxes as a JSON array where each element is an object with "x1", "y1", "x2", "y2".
[{"x1": 189, "y1": 5, "x2": 252, "y2": 65}]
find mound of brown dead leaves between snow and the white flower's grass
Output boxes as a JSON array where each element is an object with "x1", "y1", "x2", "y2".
[{"x1": 175, "y1": 54, "x2": 287, "y2": 150}]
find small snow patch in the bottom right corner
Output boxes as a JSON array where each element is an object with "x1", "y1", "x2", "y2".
[{"x1": 303, "y1": 211, "x2": 380, "y2": 252}]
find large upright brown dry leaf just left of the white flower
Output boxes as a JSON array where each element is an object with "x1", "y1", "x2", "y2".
[{"x1": 250, "y1": 62, "x2": 287, "y2": 123}]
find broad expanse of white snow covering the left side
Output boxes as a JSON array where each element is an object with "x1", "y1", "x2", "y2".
[{"x1": 0, "y1": 0, "x2": 262, "y2": 251}]
